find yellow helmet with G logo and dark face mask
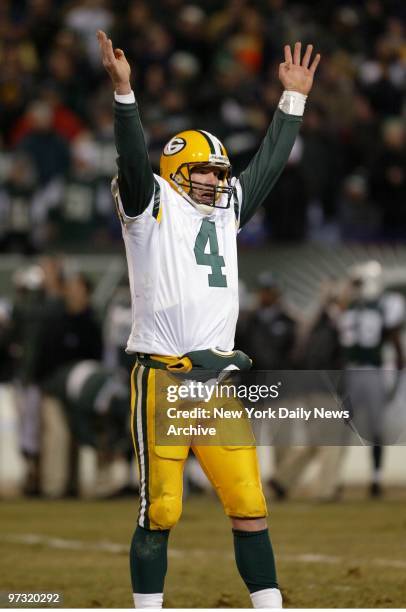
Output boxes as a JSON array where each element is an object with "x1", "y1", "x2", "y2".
[{"x1": 160, "y1": 130, "x2": 233, "y2": 214}]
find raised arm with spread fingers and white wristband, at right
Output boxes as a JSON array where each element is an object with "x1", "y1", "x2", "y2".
[{"x1": 239, "y1": 42, "x2": 320, "y2": 227}]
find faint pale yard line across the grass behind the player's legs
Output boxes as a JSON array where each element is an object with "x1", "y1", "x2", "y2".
[{"x1": 0, "y1": 533, "x2": 406, "y2": 569}]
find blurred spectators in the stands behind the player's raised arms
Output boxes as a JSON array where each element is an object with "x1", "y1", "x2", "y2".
[{"x1": 0, "y1": 0, "x2": 406, "y2": 253}]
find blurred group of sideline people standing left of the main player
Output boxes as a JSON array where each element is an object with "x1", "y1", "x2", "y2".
[{"x1": 0, "y1": 257, "x2": 135, "y2": 497}]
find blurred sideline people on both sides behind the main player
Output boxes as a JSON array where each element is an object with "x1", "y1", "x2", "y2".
[{"x1": 0, "y1": 257, "x2": 406, "y2": 501}]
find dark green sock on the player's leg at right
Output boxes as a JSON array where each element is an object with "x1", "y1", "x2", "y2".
[{"x1": 233, "y1": 529, "x2": 279, "y2": 593}]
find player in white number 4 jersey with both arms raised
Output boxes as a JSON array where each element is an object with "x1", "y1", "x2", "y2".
[{"x1": 97, "y1": 31, "x2": 320, "y2": 608}]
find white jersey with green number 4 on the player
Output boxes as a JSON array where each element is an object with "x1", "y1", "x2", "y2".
[{"x1": 113, "y1": 175, "x2": 241, "y2": 356}]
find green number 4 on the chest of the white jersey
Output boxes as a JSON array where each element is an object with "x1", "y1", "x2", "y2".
[{"x1": 194, "y1": 219, "x2": 227, "y2": 287}]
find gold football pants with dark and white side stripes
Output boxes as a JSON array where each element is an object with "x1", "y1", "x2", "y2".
[{"x1": 131, "y1": 363, "x2": 267, "y2": 530}]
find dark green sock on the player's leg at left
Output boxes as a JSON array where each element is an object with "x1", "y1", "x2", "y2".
[{"x1": 130, "y1": 525, "x2": 169, "y2": 593}]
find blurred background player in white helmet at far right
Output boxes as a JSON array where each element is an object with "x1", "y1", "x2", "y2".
[{"x1": 338, "y1": 261, "x2": 405, "y2": 497}]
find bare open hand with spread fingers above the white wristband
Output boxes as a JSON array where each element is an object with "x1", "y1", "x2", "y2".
[{"x1": 279, "y1": 42, "x2": 321, "y2": 96}]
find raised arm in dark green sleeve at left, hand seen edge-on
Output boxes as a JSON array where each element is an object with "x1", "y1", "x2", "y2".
[{"x1": 97, "y1": 30, "x2": 154, "y2": 217}]
